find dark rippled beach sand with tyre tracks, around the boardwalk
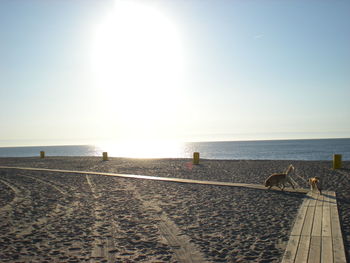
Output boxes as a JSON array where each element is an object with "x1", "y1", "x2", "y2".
[{"x1": 0, "y1": 157, "x2": 350, "y2": 262}]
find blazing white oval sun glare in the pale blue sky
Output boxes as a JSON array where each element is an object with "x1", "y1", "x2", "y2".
[{"x1": 91, "y1": 1, "x2": 184, "y2": 142}]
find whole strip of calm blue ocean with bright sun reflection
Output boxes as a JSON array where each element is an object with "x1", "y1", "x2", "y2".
[{"x1": 0, "y1": 139, "x2": 350, "y2": 160}]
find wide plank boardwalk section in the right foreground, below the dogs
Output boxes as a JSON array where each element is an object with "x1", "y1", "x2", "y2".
[{"x1": 282, "y1": 191, "x2": 346, "y2": 263}]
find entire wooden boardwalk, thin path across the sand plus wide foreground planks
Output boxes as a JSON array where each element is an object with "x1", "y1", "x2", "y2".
[{"x1": 0, "y1": 166, "x2": 346, "y2": 263}]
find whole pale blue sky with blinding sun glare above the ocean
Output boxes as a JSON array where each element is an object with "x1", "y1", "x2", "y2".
[{"x1": 0, "y1": 0, "x2": 350, "y2": 147}]
